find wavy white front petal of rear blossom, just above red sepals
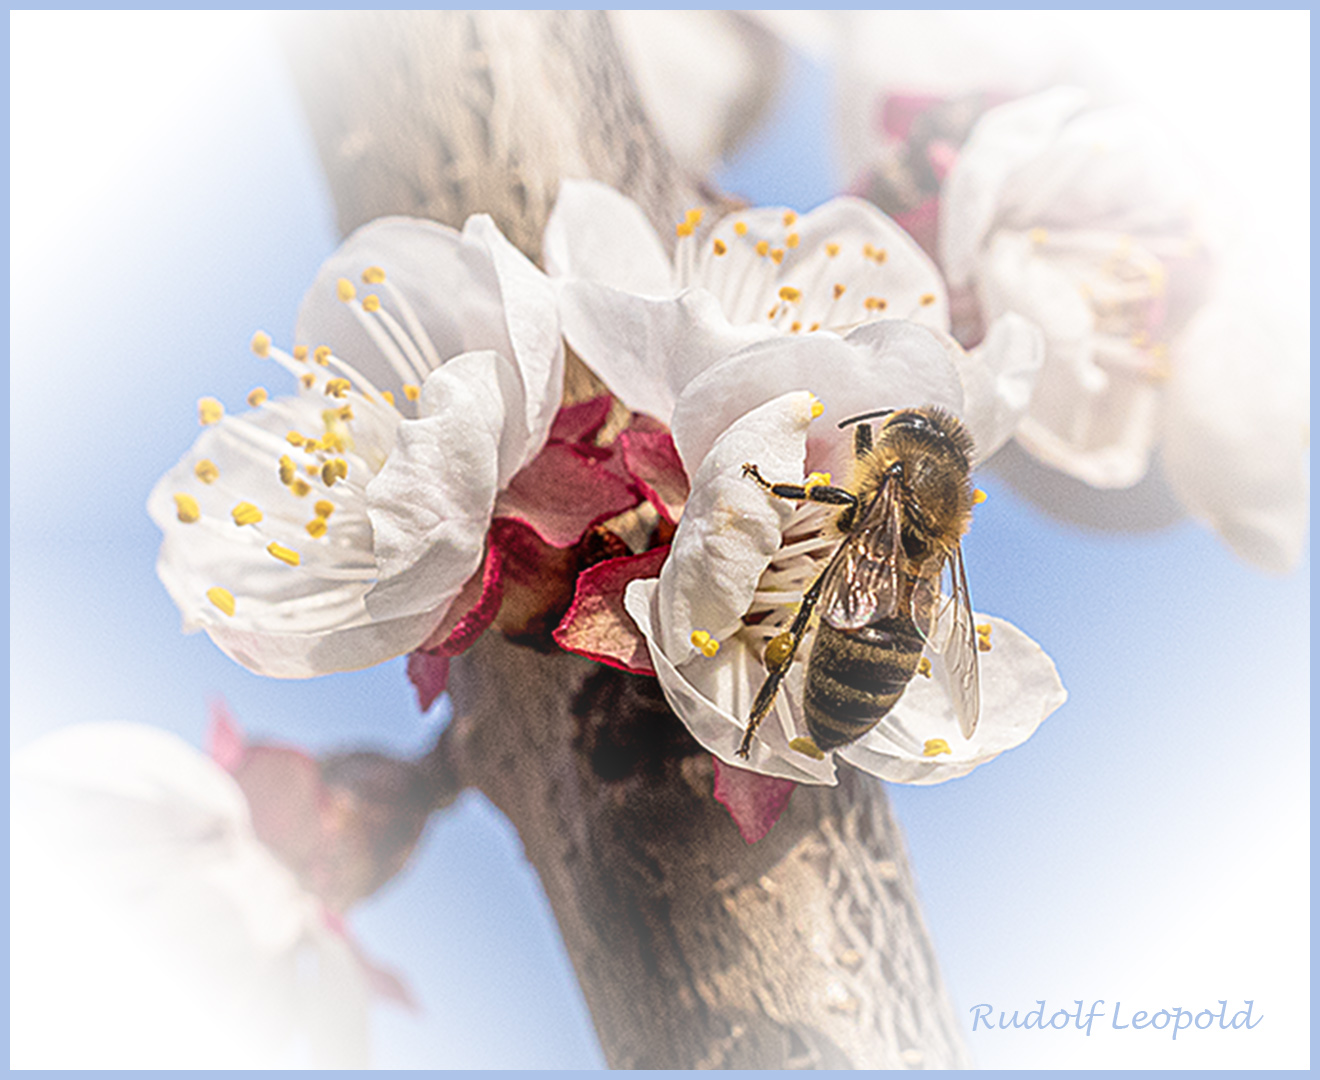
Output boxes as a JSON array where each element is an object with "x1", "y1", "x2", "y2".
[{"x1": 560, "y1": 281, "x2": 774, "y2": 422}]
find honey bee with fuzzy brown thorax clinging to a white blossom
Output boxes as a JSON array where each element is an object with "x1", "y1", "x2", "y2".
[{"x1": 738, "y1": 407, "x2": 981, "y2": 758}]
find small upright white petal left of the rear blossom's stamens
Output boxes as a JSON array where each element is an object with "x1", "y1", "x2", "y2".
[{"x1": 544, "y1": 180, "x2": 677, "y2": 294}]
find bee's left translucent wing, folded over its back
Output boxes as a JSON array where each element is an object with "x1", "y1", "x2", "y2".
[{"x1": 821, "y1": 472, "x2": 903, "y2": 630}]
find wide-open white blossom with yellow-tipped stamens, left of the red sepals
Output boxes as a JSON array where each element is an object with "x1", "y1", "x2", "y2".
[{"x1": 148, "y1": 215, "x2": 564, "y2": 677}]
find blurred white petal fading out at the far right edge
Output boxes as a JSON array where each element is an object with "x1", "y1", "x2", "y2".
[{"x1": 1163, "y1": 293, "x2": 1309, "y2": 573}]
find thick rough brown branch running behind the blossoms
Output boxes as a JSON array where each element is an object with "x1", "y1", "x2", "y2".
[{"x1": 288, "y1": 12, "x2": 966, "y2": 1068}]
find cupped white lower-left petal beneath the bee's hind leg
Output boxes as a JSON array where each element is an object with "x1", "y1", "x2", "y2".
[{"x1": 623, "y1": 578, "x2": 834, "y2": 784}]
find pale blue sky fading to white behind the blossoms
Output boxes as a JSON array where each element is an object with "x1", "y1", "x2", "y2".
[{"x1": 11, "y1": 13, "x2": 1309, "y2": 1068}]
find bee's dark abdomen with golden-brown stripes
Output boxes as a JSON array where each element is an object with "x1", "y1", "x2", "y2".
[{"x1": 804, "y1": 618, "x2": 924, "y2": 750}]
